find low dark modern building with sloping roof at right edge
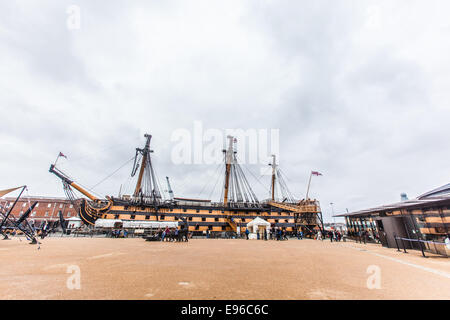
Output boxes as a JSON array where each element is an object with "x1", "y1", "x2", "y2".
[{"x1": 337, "y1": 183, "x2": 450, "y2": 256}]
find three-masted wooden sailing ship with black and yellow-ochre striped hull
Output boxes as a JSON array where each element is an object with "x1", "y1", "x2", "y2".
[{"x1": 49, "y1": 134, "x2": 323, "y2": 235}]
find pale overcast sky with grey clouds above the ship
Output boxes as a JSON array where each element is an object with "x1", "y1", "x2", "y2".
[{"x1": 0, "y1": 0, "x2": 450, "y2": 218}]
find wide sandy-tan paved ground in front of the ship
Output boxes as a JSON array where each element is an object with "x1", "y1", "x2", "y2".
[{"x1": 0, "y1": 238, "x2": 450, "y2": 299}]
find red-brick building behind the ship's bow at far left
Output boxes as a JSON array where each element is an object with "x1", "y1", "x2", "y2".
[{"x1": 0, "y1": 197, "x2": 78, "y2": 227}]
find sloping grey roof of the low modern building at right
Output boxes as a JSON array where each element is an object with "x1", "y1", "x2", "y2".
[{"x1": 335, "y1": 183, "x2": 450, "y2": 217}]
